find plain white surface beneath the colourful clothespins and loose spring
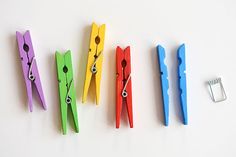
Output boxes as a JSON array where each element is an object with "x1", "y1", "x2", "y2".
[{"x1": 0, "y1": 0, "x2": 236, "y2": 157}]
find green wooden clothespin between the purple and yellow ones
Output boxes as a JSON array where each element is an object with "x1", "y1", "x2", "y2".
[{"x1": 56, "y1": 51, "x2": 79, "y2": 134}]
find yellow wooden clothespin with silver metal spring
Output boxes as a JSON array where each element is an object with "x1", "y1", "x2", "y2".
[{"x1": 82, "y1": 23, "x2": 105, "y2": 105}]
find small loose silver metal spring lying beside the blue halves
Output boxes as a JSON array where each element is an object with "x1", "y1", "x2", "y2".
[{"x1": 208, "y1": 78, "x2": 227, "y2": 102}]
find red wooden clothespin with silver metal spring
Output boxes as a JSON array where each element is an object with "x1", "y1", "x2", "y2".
[{"x1": 116, "y1": 46, "x2": 133, "y2": 128}]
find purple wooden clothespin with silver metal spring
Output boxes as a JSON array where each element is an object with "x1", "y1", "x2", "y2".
[{"x1": 16, "y1": 31, "x2": 47, "y2": 112}]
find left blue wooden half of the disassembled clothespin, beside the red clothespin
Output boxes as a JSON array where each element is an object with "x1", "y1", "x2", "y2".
[{"x1": 157, "y1": 45, "x2": 169, "y2": 126}]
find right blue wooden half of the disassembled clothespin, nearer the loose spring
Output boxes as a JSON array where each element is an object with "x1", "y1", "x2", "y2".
[{"x1": 177, "y1": 44, "x2": 188, "y2": 125}]
